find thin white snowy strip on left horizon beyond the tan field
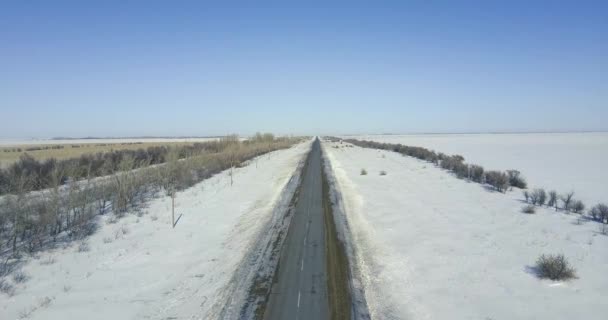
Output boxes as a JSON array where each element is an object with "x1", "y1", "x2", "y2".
[{"x1": 0, "y1": 138, "x2": 218, "y2": 147}]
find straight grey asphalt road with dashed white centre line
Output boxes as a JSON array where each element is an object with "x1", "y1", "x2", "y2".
[{"x1": 264, "y1": 140, "x2": 329, "y2": 320}]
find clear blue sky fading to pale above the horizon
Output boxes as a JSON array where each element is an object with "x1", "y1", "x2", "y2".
[{"x1": 0, "y1": 1, "x2": 608, "y2": 138}]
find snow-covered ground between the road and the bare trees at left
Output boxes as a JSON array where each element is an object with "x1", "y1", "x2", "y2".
[{"x1": 0, "y1": 142, "x2": 310, "y2": 319}]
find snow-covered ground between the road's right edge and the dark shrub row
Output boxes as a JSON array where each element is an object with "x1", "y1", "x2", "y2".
[{"x1": 323, "y1": 141, "x2": 608, "y2": 320}]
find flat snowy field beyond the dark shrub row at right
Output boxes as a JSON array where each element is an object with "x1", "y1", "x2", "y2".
[{"x1": 344, "y1": 132, "x2": 608, "y2": 206}]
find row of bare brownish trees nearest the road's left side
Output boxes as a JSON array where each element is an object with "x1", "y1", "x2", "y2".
[{"x1": 0, "y1": 136, "x2": 299, "y2": 254}]
